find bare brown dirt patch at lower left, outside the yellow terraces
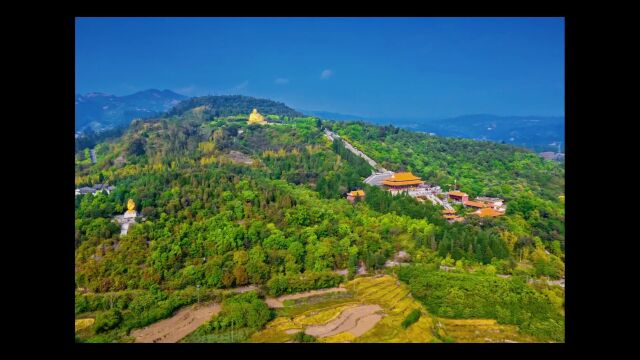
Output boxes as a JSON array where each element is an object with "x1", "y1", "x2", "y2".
[{"x1": 131, "y1": 303, "x2": 221, "y2": 343}]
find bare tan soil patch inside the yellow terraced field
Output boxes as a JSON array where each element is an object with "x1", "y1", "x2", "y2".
[{"x1": 305, "y1": 305, "x2": 382, "y2": 338}]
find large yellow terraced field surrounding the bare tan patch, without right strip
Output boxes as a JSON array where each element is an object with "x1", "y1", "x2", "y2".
[{"x1": 251, "y1": 276, "x2": 440, "y2": 342}]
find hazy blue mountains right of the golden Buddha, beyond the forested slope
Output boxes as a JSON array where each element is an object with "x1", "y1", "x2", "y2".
[{"x1": 301, "y1": 110, "x2": 565, "y2": 152}]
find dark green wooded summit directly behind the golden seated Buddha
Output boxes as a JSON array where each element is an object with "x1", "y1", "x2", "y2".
[{"x1": 167, "y1": 95, "x2": 303, "y2": 117}]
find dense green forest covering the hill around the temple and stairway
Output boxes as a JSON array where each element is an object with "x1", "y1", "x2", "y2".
[{"x1": 75, "y1": 105, "x2": 564, "y2": 341}]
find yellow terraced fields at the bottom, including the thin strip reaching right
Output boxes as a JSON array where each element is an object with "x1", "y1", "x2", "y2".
[{"x1": 251, "y1": 276, "x2": 536, "y2": 343}]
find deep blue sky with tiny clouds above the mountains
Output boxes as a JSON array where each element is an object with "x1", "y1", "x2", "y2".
[{"x1": 76, "y1": 18, "x2": 564, "y2": 118}]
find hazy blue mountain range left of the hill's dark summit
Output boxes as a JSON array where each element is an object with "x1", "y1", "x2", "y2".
[{"x1": 75, "y1": 89, "x2": 187, "y2": 131}]
